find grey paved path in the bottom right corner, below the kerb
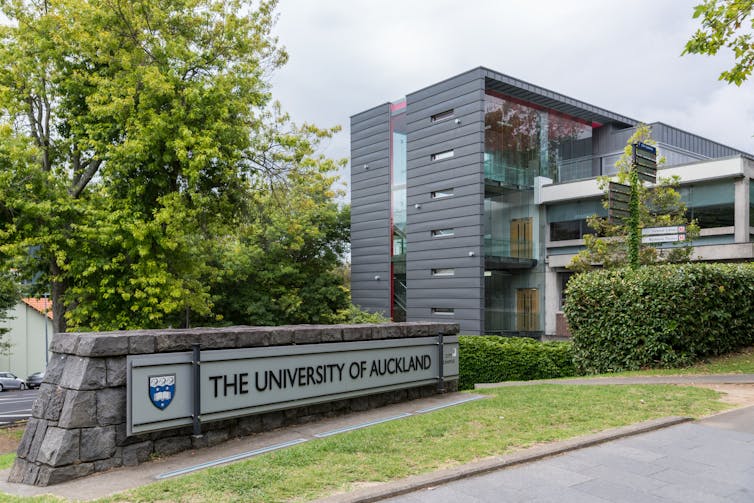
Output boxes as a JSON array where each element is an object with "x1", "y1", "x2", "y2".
[{"x1": 386, "y1": 406, "x2": 754, "y2": 503}]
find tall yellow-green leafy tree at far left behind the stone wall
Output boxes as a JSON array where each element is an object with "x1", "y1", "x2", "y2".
[{"x1": 0, "y1": 0, "x2": 286, "y2": 331}]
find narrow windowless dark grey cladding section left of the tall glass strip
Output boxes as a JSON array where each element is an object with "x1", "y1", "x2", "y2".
[{"x1": 350, "y1": 104, "x2": 390, "y2": 312}]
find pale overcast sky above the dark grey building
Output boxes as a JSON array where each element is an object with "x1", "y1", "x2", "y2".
[{"x1": 273, "y1": 0, "x2": 754, "y2": 197}]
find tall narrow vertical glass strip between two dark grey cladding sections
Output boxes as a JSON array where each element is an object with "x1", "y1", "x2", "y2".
[{"x1": 390, "y1": 100, "x2": 407, "y2": 321}]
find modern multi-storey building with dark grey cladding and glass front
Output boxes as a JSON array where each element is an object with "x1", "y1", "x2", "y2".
[{"x1": 351, "y1": 67, "x2": 754, "y2": 337}]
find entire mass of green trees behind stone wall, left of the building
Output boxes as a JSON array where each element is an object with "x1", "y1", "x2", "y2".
[{"x1": 0, "y1": 0, "x2": 348, "y2": 331}]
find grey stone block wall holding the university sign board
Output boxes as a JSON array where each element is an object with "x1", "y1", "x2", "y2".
[{"x1": 8, "y1": 323, "x2": 458, "y2": 486}]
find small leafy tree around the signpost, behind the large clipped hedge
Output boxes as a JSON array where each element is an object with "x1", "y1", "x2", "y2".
[{"x1": 568, "y1": 125, "x2": 699, "y2": 271}]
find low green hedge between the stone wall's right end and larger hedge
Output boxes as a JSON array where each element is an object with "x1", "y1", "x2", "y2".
[{"x1": 458, "y1": 335, "x2": 576, "y2": 389}]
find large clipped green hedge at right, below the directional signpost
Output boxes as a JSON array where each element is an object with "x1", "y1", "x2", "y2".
[{"x1": 564, "y1": 264, "x2": 754, "y2": 373}]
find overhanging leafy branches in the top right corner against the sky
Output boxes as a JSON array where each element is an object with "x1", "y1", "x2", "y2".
[{"x1": 682, "y1": 0, "x2": 754, "y2": 86}]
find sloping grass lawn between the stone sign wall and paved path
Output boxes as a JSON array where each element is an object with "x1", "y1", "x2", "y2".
[{"x1": 81, "y1": 385, "x2": 728, "y2": 502}]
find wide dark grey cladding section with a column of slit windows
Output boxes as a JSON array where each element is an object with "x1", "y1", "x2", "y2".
[{"x1": 406, "y1": 71, "x2": 484, "y2": 333}]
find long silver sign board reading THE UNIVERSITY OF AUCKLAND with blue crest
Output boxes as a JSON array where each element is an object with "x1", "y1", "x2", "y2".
[{"x1": 127, "y1": 336, "x2": 458, "y2": 435}]
